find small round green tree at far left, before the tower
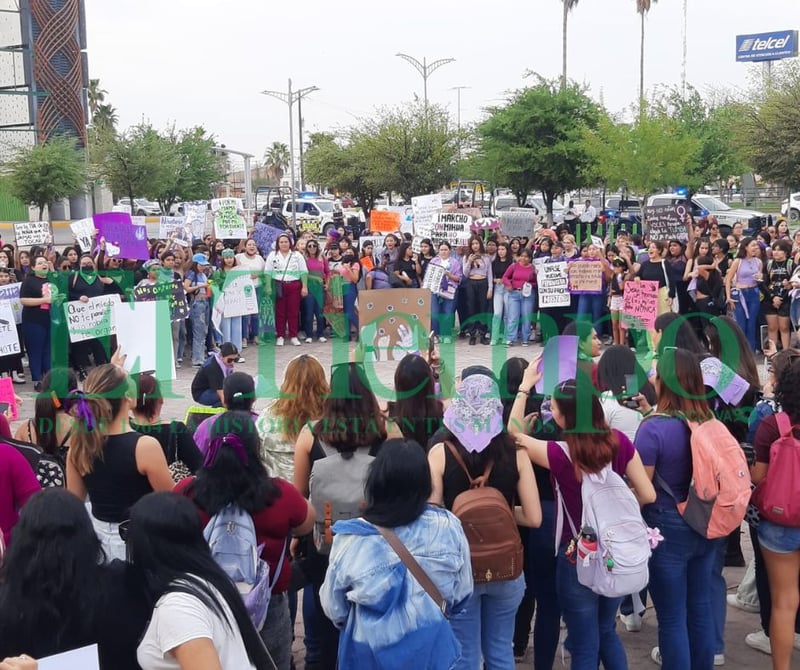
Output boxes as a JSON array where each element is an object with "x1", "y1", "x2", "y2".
[{"x1": 7, "y1": 137, "x2": 86, "y2": 220}]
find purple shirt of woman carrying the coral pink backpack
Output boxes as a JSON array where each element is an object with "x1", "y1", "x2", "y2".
[{"x1": 634, "y1": 416, "x2": 692, "y2": 509}]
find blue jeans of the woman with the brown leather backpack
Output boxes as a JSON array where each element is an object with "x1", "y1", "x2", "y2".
[{"x1": 450, "y1": 575, "x2": 528, "y2": 670}]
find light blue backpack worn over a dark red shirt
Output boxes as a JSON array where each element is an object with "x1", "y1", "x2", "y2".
[{"x1": 203, "y1": 503, "x2": 288, "y2": 631}]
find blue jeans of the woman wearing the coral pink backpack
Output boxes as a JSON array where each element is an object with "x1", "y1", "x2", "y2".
[{"x1": 644, "y1": 505, "x2": 724, "y2": 670}]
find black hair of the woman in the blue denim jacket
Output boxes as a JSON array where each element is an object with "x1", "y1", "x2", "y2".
[{"x1": 364, "y1": 439, "x2": 431, "y2": 528}]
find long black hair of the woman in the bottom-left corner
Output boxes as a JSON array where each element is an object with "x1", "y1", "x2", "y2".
[{"x1": 0, "y1": 488, "x2": 105, "y2": 657}]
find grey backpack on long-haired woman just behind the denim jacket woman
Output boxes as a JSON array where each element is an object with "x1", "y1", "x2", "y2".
[{"x1": 308, "y1": 438, "x2": 375, "y2": 555}]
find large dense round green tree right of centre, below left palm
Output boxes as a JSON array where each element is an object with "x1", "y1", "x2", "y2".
[{"x1": 478, "y1": 77, "x2": 601, "y2": 216}]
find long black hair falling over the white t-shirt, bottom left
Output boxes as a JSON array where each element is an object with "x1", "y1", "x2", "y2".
[{"x1": 128, "y1": 492, "x2": 273, "y2": 670}]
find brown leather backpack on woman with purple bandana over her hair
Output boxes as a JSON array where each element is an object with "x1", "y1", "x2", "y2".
[{"x1": 445, "y1": 442, "x2": 523, "y2": 584}]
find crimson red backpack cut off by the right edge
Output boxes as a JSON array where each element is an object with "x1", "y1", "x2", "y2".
[{"x1": 753, "y1": 412, "x2": 800, "y2": 528}]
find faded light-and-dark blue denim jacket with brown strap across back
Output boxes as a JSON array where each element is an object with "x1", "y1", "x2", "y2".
[{"x1": 320, "y1": 506, "x2": 472, "y2": 670}]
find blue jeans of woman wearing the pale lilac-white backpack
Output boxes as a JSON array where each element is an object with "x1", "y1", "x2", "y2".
[{"x1": 556, "y1": 545, "x2": 624, "y2": 670}]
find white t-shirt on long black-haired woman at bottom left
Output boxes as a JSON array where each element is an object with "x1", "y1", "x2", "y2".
[{"x1": 136, "y1": 586, "x2": 255, "y2": 670}]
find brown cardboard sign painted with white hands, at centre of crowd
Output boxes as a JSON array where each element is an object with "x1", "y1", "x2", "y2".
[{"x1": 358, "y1": 288, "x2": 431, "y2": 360}]
